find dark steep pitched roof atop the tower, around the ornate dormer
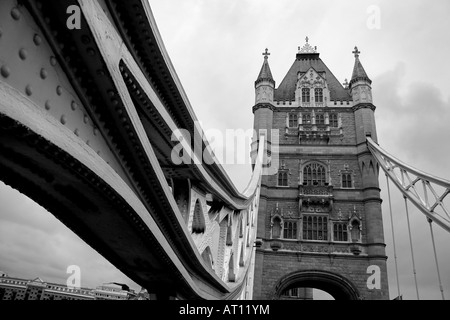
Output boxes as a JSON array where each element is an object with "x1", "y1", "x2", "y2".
[{"x1": 274, "y1": 53, "x2": 352, "y2": 101}]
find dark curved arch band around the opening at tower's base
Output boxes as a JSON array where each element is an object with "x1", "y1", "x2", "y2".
[{"x1": 272, "y1": 270, "x2": 361, "y2": 300}]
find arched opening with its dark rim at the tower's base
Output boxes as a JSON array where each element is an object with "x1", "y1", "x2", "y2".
[{"x1": 273, "y1": 270, "x2": 360, "y2": 300}]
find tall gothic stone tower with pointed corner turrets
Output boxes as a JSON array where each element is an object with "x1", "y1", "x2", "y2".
[{"x1": 253, "y1": 38, "x2": 389, "y2": 300}]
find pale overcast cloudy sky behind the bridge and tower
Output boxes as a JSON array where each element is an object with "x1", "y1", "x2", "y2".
[{"x1": 0, "y1": 0, "x2": 450, "y2": 299}]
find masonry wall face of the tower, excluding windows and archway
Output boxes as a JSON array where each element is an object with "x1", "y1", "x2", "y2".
[{"x1": 254, "y1": 103, "x2": 389, "y2": 300}]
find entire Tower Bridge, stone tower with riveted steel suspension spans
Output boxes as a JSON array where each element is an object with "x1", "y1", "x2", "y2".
[{"x1": 0, "y1": 0, "x2": 450, "y2": 300}]
